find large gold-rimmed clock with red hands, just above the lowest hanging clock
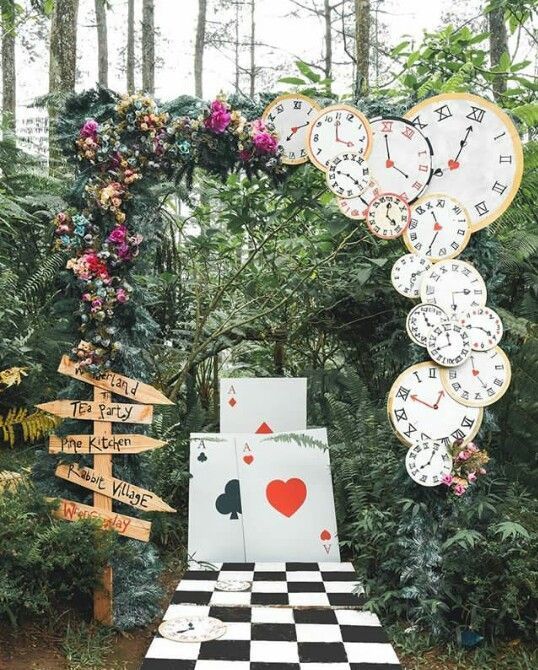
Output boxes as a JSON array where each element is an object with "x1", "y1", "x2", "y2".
[{"x1": 388, "y1": 362, "x2": 482, "y2": 446}]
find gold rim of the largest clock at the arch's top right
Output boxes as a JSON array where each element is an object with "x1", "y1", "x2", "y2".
[{"x1": 404, "y1": 92, "x2": 523, "y2": 233}]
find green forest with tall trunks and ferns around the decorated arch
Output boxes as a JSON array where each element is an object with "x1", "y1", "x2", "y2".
[{"x1": 0, "y1": 0, "x2": 538, "y2": 670}]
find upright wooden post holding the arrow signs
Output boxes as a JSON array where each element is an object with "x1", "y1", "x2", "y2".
[{"x1": 93, "y1": 387, "x2": 113, "y2": 626}]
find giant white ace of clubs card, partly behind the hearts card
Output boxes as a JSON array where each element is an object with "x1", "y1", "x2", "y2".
[{"x1": 184, "y1": 433, "x2": 246, "y2": 562}]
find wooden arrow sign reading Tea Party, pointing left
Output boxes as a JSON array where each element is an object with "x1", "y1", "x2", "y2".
[{"x1": 36, "y1": 400, "x2": 153, "y2": 423}]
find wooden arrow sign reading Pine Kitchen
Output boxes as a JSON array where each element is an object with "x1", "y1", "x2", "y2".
[{"x1": 49, "y1": 433, "x2": 167, "y2": 456}]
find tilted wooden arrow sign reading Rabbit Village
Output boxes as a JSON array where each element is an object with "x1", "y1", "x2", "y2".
[{"x1": 56, "y1": 463, "x2": 176, "y2": 512}]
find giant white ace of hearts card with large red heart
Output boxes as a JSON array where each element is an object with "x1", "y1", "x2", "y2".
[{"x1": 236, "y1": 429, "x2": 340, "y2": 562}]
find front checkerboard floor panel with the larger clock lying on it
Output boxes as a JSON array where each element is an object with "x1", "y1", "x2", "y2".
[{"x1": 141, "y1": 605, "x2": 401, "y2": 670}]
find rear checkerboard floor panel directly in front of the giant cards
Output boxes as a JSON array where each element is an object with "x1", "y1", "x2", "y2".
[{"x1": 172, "y1": 563, "x2": 364, "y2": 608}]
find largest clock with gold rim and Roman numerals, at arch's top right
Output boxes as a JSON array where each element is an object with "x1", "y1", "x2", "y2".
[{"x1": 405, "y1": 93, "x2": 523, "y2": 232}]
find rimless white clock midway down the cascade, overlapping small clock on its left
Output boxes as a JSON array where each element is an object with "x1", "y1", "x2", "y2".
[{"x1": 420, "y1": 260, "x2": 488, "y2": 316}]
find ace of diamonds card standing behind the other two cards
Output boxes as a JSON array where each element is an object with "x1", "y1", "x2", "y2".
[{"x1": 220, "y1": 377, "x2": 306, "y2": 435}]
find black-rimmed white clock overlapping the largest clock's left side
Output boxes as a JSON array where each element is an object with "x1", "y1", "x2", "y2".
[{"x1": 368, "y1": 117, "x2": 432, "y2": 202}]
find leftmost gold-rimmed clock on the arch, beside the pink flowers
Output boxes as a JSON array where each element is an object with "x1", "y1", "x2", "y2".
[{"x1": 262, "y1": 93, "x2": 321, "y2": 165}]
